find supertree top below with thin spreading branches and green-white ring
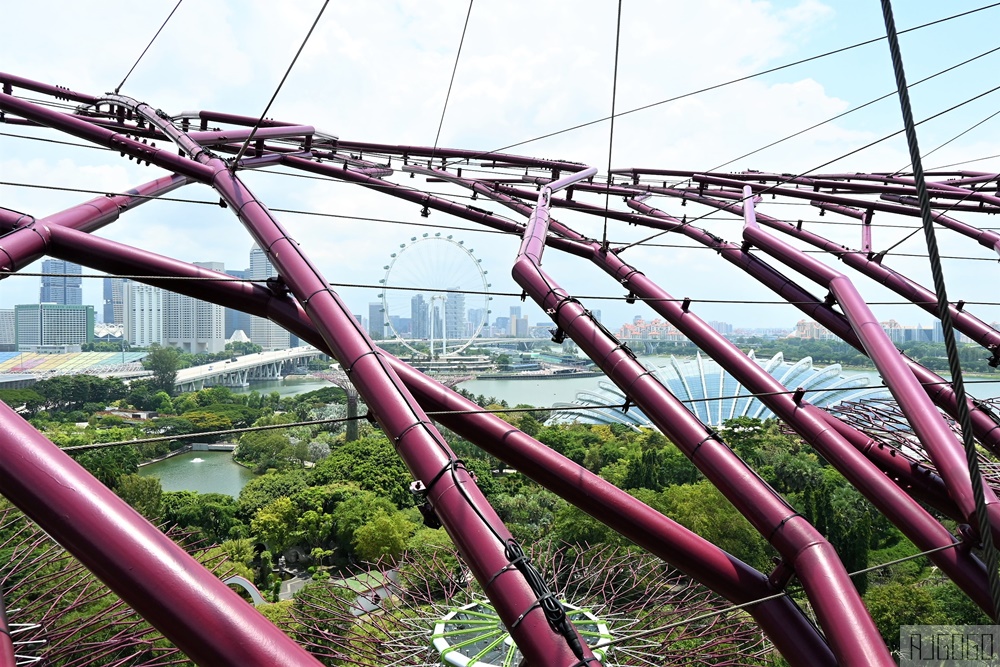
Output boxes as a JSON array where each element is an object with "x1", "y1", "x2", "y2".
[{"x1": 286, "y1": 546, "x2": 770, "y2": 667}]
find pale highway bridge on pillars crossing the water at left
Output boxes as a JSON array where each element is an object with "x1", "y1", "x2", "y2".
[{"x1": 174, "y1": 346, "x2": 324, "y2": 392}]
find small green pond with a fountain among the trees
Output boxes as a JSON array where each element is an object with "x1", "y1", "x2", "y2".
[{"x1": 139, "y1": 452, "x2": 254, "y2": 498}]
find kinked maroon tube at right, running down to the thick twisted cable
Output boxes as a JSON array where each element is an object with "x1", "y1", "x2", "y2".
[{"x1": 743, "y1": 186, "x2": 1000, "y2": 531}]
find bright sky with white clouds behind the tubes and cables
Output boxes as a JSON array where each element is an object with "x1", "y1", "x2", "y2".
[{"x1": 0, "y1": 0, "x2": 1000, "y2": 328}]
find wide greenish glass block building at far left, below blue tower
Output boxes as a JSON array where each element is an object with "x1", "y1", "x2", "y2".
[{"x1": 14, "y1": 303, "x2": 94, "y2": 352}]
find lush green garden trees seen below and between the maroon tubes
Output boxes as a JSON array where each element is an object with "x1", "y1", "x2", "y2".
[{"x1": 0, "y1": 376, "x2": 987, "y2": 660}]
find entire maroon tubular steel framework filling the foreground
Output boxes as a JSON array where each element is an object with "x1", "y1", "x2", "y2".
[{"x1": 0, "y1": 73, "x2": 1000, "y2": 667}]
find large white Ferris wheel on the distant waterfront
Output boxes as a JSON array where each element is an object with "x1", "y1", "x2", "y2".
[{"x1": 379, "y1": 232, "x2": 493, "y2": 357}]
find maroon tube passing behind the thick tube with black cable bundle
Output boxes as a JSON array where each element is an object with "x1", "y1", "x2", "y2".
[{"x1": 23, "y1": 220, "x2": 835, "y2": 666}]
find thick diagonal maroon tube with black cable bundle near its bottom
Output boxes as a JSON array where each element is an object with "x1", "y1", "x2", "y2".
[{"x1": 0, "y1": 88, "x2": 593, "y2": 665}]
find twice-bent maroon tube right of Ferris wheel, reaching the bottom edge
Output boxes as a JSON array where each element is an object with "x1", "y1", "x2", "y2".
[{"x1": 512, "y1": 177, "x2": 894, "y2": 665}]
